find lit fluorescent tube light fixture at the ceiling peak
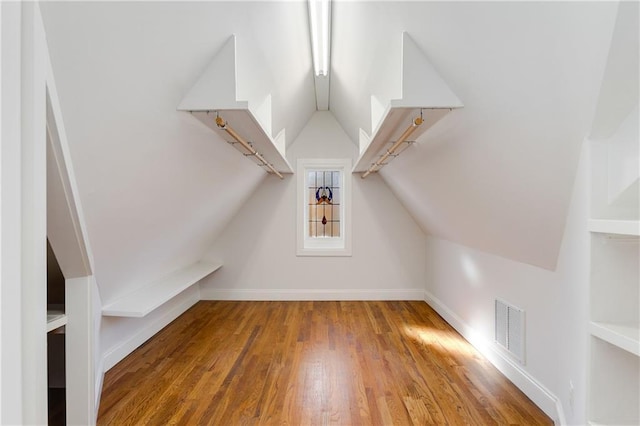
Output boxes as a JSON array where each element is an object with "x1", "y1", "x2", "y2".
[{"x1": 309, "y1": 0, "x2": 331, "y2": 76}]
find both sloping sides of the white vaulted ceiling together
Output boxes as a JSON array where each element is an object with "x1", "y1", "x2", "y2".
[{"x1": 41, "y1": 1, "x2": 617, "y2": 299}]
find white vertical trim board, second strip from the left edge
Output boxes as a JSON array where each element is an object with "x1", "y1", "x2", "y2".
[{"x1": 14, "y1": 3, "x2": 47, "y2": 424}]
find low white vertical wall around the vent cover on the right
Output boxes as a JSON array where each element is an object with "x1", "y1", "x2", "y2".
[{"x1": 426, "y1": 237, "x2": 557, "y2": 416}]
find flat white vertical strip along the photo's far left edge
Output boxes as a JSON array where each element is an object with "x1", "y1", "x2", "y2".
[{"x1": 0, "y1": 2, "x2": 22, "y2": 424}]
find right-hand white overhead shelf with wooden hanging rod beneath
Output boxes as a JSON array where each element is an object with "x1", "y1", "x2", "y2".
[{"x1": 353, "y1": 32, "x2": 463, "y2": 173}]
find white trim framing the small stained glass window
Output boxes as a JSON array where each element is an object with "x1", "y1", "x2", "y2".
[{"x1": 296, "y1": 158, "x2": 351, "y2": 256}]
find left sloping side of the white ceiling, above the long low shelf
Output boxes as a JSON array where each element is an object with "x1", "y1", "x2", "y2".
[{"x1": 41, "y1": 2, "x2": 315, "y2": 302}]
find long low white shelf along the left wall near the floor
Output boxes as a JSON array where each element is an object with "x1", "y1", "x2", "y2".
[{"x1": 102, "y1": 262, "x2": 222, "y2": 318}]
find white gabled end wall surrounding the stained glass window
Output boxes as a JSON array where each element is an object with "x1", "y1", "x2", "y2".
[{"x1": 201, "y1": 112, "x2": 426, "y2": 300}]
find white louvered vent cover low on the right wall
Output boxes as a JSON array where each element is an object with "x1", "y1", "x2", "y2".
[{"x1": 495, "y1": 299, "x2": 525, "y2": 364}]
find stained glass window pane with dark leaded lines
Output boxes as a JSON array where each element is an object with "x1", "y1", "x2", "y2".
[{"x1": 307, "y1": 170, "x2": 341, "y2": 238}]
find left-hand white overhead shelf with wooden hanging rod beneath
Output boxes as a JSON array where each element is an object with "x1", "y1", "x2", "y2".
[{"x1": 178, "y1": 36, "x2": 293, "y2": 177}]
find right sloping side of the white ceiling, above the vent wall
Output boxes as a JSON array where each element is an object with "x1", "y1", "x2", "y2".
[{"x1": 330, "y1": 2, "x2": 617, "y2": 269}]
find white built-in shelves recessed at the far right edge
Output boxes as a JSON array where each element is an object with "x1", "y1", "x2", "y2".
[{"x1": 587, "y1": 79, "x2": 640, "y2": 425}]
